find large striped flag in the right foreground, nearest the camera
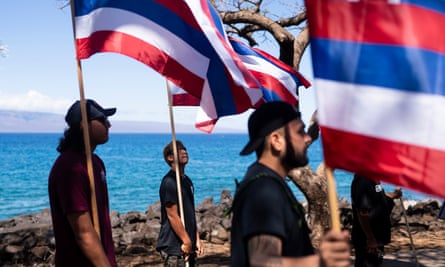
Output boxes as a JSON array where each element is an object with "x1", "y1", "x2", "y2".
[{"x1": 306, "y1": 0, "x2": 445, "y2": 197}]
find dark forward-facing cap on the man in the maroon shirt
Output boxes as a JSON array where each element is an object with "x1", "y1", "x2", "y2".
[{"x1": 65, "y1": 99, "x2": 116, "y2": 127}]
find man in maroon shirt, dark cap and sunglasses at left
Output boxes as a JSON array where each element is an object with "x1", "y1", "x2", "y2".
[{"x1": 48, "y1": 100, "x2": 116, "y2": 267}]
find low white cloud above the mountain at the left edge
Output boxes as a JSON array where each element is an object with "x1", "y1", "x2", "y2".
[{"x1": 0, "y1": 90, "x2": 73, "y2": 114}]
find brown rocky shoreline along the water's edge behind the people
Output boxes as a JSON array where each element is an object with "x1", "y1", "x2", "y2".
[{"x1": 0, "y1": 191, "x2": 445, "y2": 267}]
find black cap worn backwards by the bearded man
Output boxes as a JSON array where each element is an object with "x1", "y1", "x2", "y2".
[{"x1": 240, "y1": 101, "x2": 301, "y2": 156}]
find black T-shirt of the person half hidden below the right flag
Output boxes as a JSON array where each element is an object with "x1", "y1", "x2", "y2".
[{"x1": 351, "y1": 175, "x2": 392, "y2": 245}]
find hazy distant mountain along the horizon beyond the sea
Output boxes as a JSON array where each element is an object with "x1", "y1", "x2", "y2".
[{"x1": 0, "y1": 110, "x2": 240, "y2": 133}]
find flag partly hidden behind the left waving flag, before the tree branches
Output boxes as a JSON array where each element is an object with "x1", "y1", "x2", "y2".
[{"x1": 170, "y1": 37, "x2": 311, "y2": 131}]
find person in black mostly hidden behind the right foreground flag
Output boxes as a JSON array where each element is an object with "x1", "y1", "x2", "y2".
[{"x1": 351, "y1": 174, "x2": 402, "y2": 267}]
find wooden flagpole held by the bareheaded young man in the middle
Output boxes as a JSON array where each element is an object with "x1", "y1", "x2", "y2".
[{"x1": 165, "y1": 79, "x2": 189, "y2": 267}]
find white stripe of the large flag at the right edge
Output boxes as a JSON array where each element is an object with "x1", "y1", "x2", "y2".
[{"x1": 314, "y1": 79, "x2": 445, "y2": 150}]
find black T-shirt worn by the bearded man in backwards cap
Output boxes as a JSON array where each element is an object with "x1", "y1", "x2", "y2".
[{"x1": 231, "y1": 163, "x2": 314, "y2": 267}]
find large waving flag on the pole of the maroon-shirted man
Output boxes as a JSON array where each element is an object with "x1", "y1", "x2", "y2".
[{"x1": 74, "y1": 0, "x2": 262, "y2": 132}]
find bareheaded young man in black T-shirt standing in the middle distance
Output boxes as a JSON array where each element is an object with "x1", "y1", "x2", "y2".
[{"x1": 156, "y1": 141, "x2": 204, "y2": 267}]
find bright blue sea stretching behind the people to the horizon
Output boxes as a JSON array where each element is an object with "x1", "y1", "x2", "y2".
[{"x1": 0, "y1": 133, "x2": 429, "y2": 220}]
